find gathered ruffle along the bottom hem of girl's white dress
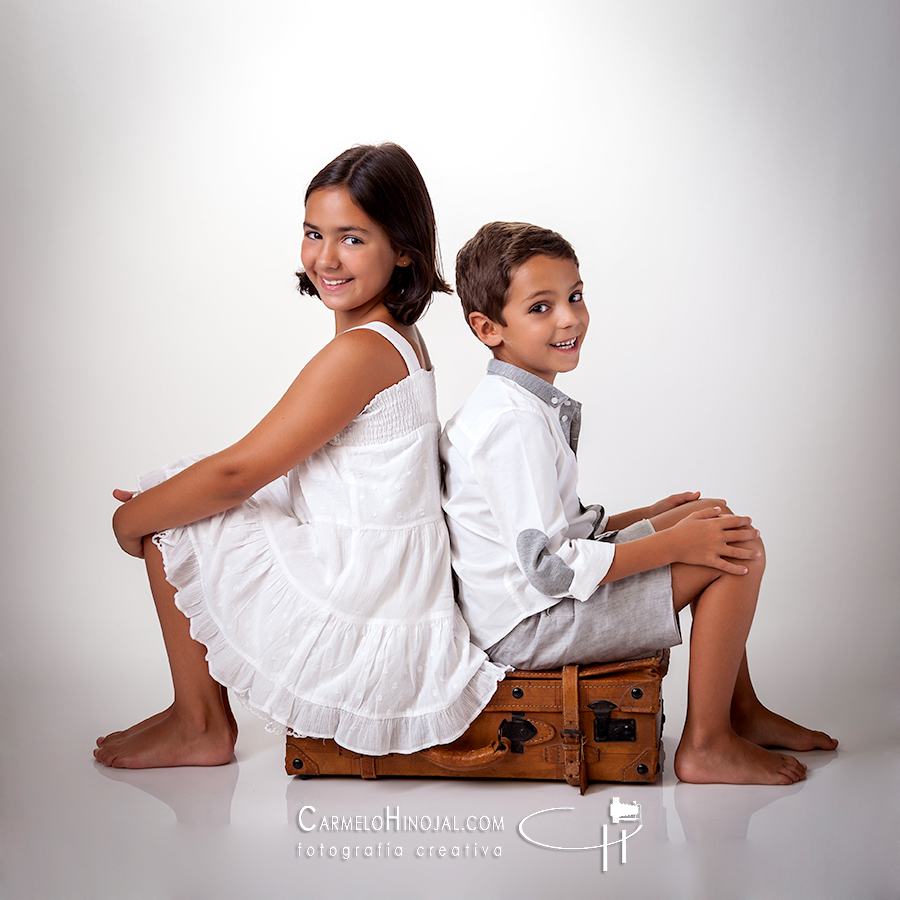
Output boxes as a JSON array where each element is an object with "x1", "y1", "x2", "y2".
[{"x1": 141, "y1": 478, "x2": 509, "y2": 756}]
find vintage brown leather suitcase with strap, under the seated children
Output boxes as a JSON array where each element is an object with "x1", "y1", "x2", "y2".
[{"x1": 285, "y1": 650, "x2": 669, "y2": 793}]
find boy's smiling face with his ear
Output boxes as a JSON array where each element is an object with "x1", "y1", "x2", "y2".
[{"x1": 469, "y1": 255, "x2": 590, "y2": 384}]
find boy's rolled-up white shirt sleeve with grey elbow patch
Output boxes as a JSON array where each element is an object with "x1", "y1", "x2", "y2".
[{"x1": 469, "y1": 409, "x2": 615, "y2": 600}]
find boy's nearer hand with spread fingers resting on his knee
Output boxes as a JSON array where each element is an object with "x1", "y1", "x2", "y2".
[{"x1": 666, "y1": 506, "x2": 760, "y2": 575}]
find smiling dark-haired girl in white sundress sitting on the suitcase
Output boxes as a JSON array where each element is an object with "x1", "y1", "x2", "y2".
[{"x1": 94, "y1": 144, "x2": 504, "y2": 768}]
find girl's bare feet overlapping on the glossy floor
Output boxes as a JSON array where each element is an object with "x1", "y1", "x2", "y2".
[{"x1": 94, "y1": 705, "x2": 234, "y2": 769}]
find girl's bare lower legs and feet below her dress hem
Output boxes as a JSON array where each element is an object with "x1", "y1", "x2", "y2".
[{"x1": 94, "y1": 538, "x2": 236, "y2": 769}]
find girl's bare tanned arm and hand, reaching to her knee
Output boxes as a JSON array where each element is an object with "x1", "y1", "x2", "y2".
[{"x1": 113, "y1": 330, "x2": 407, "y2": 556}]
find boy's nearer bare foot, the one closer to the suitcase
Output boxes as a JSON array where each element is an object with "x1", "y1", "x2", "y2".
[{"x1": 675, "y1": 732, "x2": 806, "y2": 784}]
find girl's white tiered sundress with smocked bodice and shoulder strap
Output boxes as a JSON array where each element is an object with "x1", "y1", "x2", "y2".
[{"x1": 138, "y1": 322, "x2": 505, "y2": 755}]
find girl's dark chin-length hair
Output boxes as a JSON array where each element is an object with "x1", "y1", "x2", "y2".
[{"x1": 297, "y1": 143, "x2": 450, "y2": 325}]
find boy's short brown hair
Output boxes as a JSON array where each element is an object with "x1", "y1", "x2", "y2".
[{"x1": 456, "y1": 222, "x2": 578, "y2": 327}]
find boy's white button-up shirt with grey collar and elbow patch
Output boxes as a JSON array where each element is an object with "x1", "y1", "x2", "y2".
[{"x1": 440, "y1": 360, "x2": 615, "y2": 649}]
